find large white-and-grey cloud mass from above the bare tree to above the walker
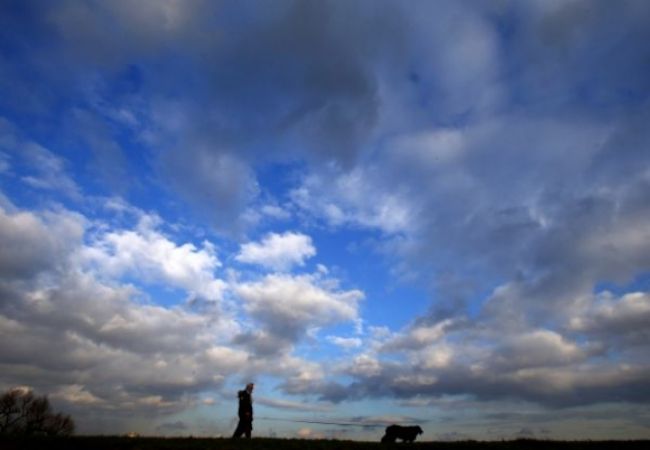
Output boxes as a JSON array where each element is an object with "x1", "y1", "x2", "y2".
[{"x1": 0, "y1": 200, "x2": 370, "y2": 430}]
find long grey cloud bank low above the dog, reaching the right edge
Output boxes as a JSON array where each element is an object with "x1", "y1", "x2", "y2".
[{"x1": 300, "y1": 284, "x2": 650, "y2": 407}]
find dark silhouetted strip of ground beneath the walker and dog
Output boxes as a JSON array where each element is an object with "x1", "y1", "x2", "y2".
[{"x1": 0, "y1": 436, "x2": 650, "y2": 450}]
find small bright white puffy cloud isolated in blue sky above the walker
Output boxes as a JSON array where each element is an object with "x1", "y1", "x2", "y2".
[{"x1": 235, "y1": 231, "x2": 316, "y2": 271}]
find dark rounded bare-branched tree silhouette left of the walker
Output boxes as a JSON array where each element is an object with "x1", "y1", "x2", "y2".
[{"x1": 0, "y1": 389, "x2": 74, "y2": 436}]
